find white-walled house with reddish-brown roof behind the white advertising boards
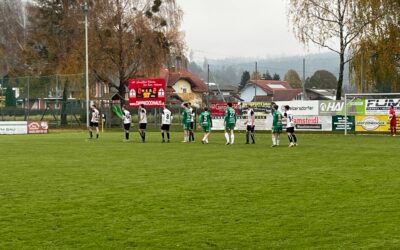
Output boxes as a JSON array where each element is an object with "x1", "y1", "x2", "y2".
[{"x1": 239, "y1": 80, "x2": 302, "y2": 102}]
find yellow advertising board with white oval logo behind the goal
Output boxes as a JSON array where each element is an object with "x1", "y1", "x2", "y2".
[{"x1": 355, "y1": 115, "x2": 390, "y2": 132}]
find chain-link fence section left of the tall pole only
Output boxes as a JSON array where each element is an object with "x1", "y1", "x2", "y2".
[{"x1": 0, "y1": 74, "x2": 86, "y2": 126}]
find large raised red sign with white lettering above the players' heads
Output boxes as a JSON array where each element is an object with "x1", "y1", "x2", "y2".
[{"x1": 128, "y1": 78, "x2": 166, "y2": 108}]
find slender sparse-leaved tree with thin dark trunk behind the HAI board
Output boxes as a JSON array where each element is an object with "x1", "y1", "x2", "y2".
[{"x1": 288, "y1": 0, "x2": 370, "y2": 100}]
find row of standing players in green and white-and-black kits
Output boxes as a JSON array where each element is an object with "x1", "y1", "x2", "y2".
[{"x1": 89, "y1": 102, "x2": 297, "y2": 147}]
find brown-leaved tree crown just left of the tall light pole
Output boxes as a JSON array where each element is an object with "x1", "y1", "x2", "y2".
[{"x1": 27, "y1": 0, "x2": 84, "y2": 75}]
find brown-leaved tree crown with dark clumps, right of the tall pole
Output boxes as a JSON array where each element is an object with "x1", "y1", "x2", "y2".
[{"x1": 90, "y1": 0, "x2": 183, "y2": 99}]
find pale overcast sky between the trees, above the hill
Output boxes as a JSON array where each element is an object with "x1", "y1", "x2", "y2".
[{"x1": 177, "y1": 0, "x2": 326, "y2": 60}]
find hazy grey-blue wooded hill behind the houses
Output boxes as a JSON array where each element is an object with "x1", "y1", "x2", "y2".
[{"x1": 189, "y1": 53, "x2": 349, "y2": 88}]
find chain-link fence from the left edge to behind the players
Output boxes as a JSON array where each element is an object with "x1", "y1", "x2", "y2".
[{"x1": 0, "y1": 74, "x2": 200, "y2": 129}]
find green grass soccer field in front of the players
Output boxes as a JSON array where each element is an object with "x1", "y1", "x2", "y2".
[{"x1": 0, "y1": 132, "x2": 400, "y2": 249}]
